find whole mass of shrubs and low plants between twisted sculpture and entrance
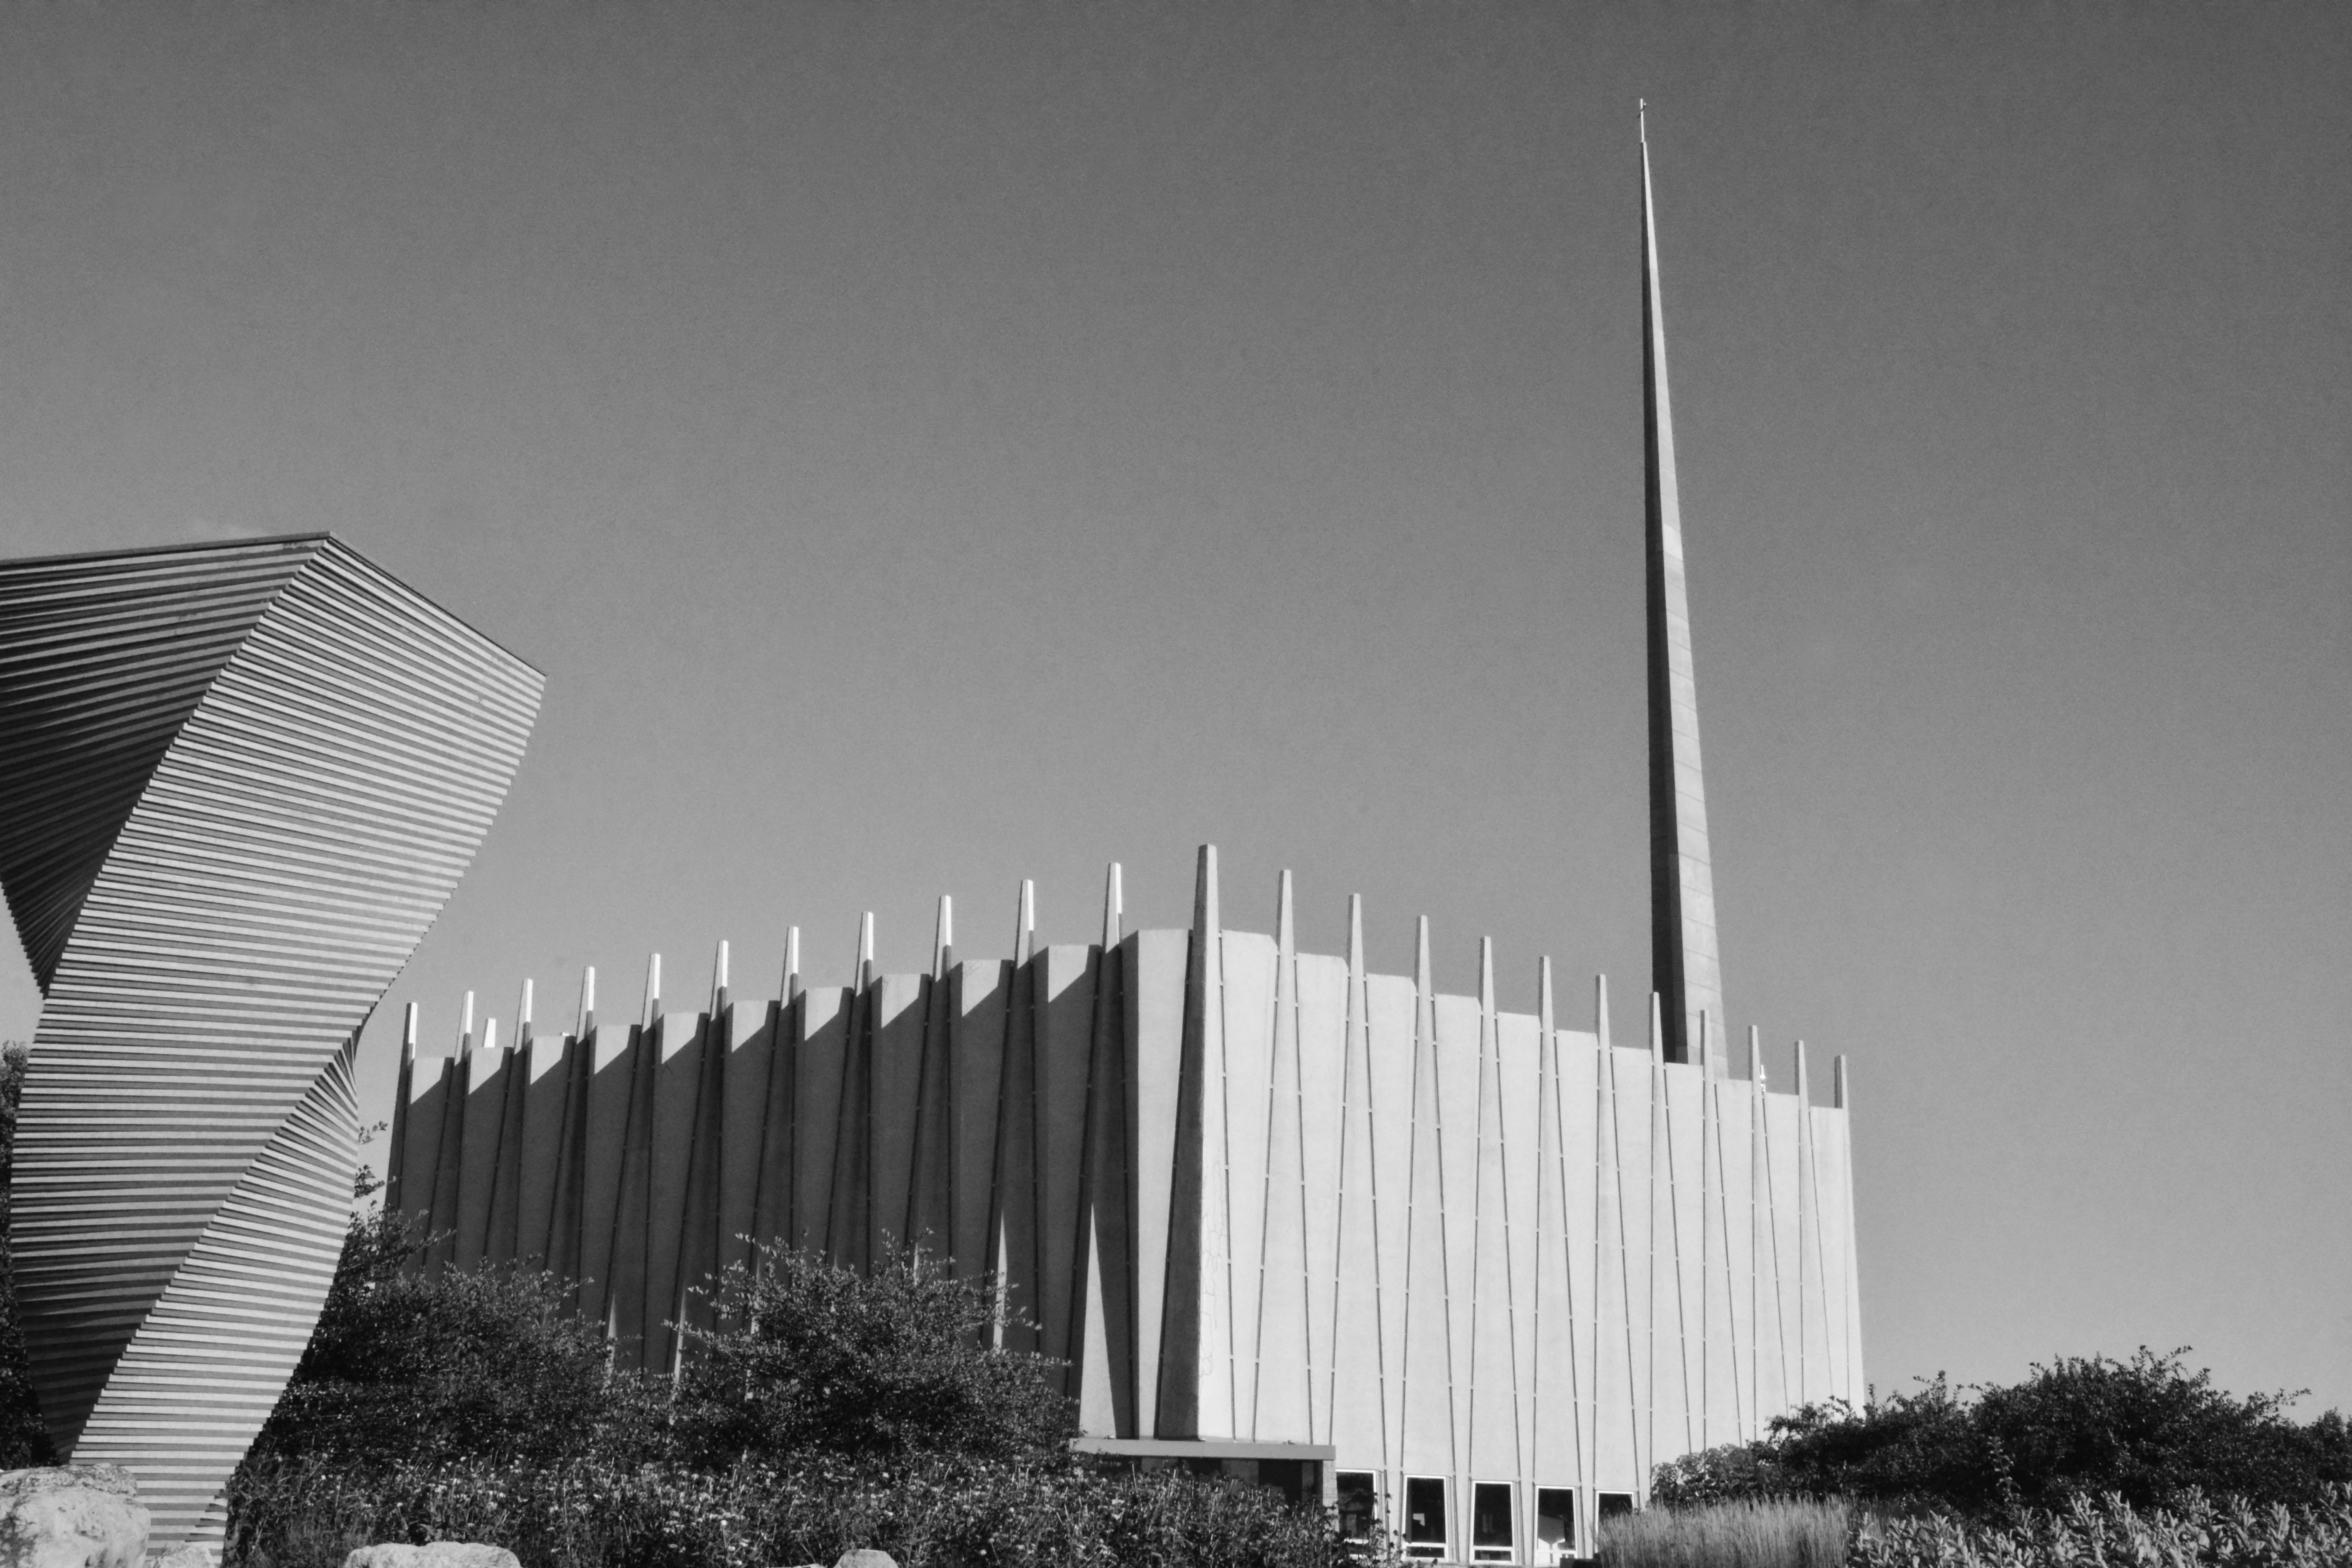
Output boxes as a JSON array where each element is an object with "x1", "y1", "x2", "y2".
[{"x1": 228, "y1": 1215, "x2": 1350, "y2": 1568}]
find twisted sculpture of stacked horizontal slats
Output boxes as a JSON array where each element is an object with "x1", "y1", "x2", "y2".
[{"x1": 0, "y1": 536, "x2": 541, "y2": 1544}]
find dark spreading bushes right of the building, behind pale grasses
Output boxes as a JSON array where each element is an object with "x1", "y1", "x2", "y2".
[{"x1": 1651, "y1": 1347, "x2": 2352, "y2": 1514}]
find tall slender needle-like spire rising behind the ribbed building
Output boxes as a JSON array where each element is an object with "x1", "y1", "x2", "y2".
[{"x1": 1642, "y1": 113, "x2": 1724, "y2": 1074}]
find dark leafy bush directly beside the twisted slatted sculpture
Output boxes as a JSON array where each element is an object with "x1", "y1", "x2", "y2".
[{"x1": 254, "y1": 1213, "x2": 661, "y2": 1465}]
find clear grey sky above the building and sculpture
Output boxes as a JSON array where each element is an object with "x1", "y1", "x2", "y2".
[{"x1": 0, "y1": 0, "x2": 2352, "y2": 1415}]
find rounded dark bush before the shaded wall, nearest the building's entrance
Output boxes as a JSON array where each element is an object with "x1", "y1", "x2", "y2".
[{"x1": 673, "y1": 1248, "x2": 1075, "y2": 1467}]
